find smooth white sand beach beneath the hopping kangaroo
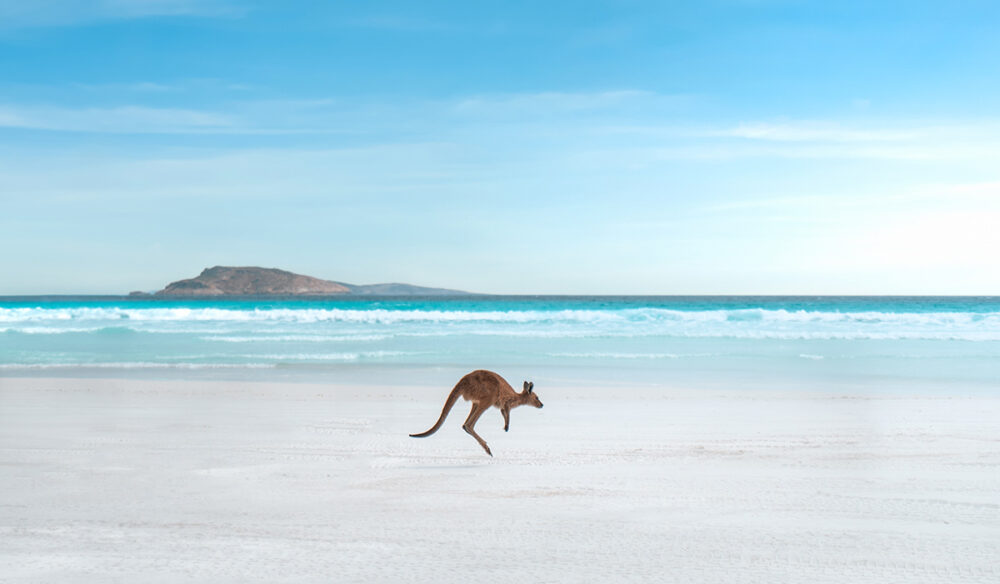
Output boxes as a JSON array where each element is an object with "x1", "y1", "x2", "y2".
[{"x1": 0, "y1": 378, "x2": 1000, "y2": 584}]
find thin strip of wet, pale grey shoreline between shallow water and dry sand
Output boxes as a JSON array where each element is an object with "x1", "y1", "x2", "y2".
[{"x1": 0, "y1": 363, "x2": 996, "y2": 398}]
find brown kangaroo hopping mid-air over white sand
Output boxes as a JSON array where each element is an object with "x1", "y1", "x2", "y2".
[{"x1": 410, "y1": 369, "x2": 542, "y2": 456}]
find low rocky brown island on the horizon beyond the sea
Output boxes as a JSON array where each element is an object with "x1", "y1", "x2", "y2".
[{"x1": 130, "y1": 266, "x2": 471, "y2": 296}]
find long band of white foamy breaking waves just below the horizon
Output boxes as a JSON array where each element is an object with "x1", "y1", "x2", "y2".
[{"x1": 0, "y1": 307, "x2": 1000, "y2": 343}]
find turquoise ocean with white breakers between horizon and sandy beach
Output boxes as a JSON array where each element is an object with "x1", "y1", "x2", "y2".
[{"x1": 0, "y1": 296, "x2": 1000, "y2": 391}]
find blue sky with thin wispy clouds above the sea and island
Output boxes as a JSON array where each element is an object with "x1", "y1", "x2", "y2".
[{"x1": 0, "y1": 0, "x2": 1000, "y2": 294}]
